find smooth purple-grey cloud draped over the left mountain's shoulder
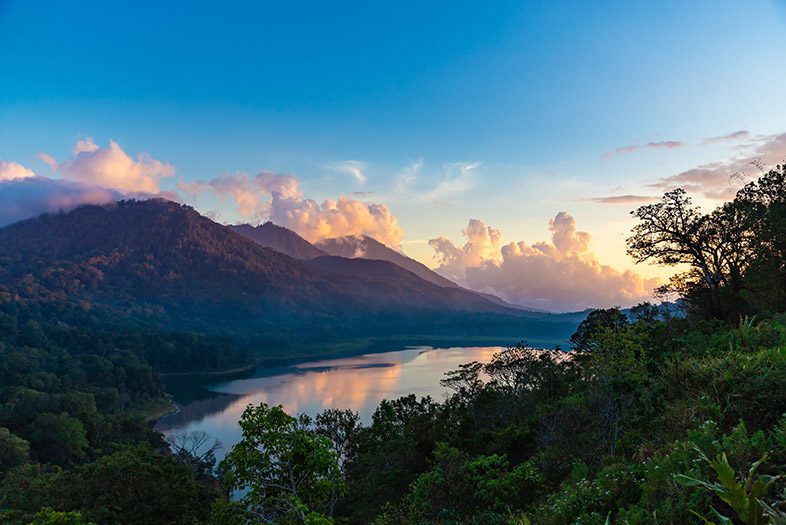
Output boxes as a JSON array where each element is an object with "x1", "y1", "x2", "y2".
[{"x1": 0, "y1": 177, "x2": 123, "y2": 226}]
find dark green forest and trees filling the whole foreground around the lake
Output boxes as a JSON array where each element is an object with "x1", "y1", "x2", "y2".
[{"x1": 0, "y1": 167, "x2": 786, "y2": 525}]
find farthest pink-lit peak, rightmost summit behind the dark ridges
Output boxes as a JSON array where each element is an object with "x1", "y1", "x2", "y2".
[{"x1": 315, "y1": 235, "x2": 459, "y2": 288}]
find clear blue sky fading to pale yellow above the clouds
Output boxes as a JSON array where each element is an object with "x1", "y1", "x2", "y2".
[{"x1": 0, "y1": 0, "x2": 786, "y2": 310}]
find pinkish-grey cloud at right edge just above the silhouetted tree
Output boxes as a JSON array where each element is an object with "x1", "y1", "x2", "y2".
[{"x1": 650, "y1": 133, "x2": 786, "y2": 200}]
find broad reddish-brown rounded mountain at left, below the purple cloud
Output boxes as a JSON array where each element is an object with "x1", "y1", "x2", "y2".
[{"x1": 0, "y1": 200, "x2": 338, "y2": 316}]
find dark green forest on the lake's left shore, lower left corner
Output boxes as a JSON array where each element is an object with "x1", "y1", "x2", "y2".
[{"x1": 0, "y1": 301, "x2": 222, "y2": 524}]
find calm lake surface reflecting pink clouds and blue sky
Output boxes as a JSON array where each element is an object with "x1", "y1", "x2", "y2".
[{"x1": 156, "y1": 347, "x2": 501, "y2": 456}]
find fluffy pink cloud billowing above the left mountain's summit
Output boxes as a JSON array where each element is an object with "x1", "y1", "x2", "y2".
[{"x1": 39, "y1": 138, "x2": 175, "y2": 194}]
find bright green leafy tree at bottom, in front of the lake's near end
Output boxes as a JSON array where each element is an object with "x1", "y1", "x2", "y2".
[{"x1": 220, "y1": 403, "x2": 344, "y2": 524}]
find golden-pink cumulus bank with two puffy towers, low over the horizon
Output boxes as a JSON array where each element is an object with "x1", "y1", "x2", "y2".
[{"x1": 429, "y1": 212, "x2": 658, "y2": 311}]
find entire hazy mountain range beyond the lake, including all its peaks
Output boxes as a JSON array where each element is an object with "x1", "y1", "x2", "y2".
[{"x1": 0, "y1": 200, "x2": 582, "y2": 372}]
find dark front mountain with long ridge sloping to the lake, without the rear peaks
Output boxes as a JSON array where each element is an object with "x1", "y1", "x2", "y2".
[{"x1": 0, "y1": 200, "x2": 575, "y2": 350}]
